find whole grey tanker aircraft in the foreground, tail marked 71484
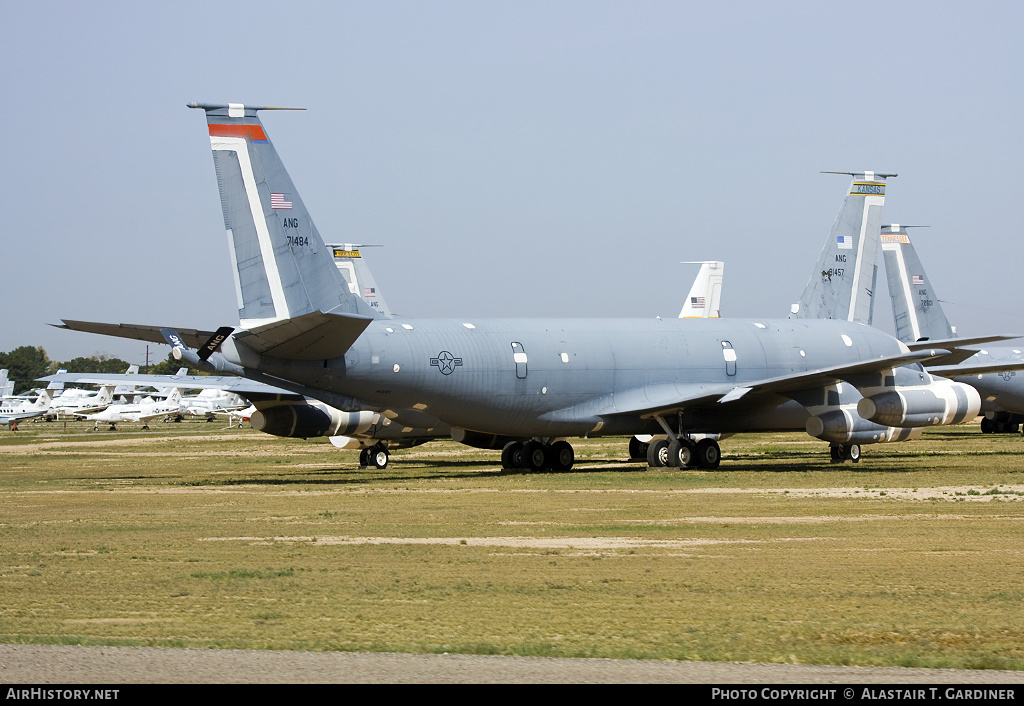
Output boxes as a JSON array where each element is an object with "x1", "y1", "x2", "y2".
[{"x1": 169, "y1": 103, "x2": 980, "y2": 470}]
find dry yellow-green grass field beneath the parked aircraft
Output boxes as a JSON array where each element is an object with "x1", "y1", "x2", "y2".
[{"x1": 0, "y1": 422, "x2": 1024, "y2": 670}]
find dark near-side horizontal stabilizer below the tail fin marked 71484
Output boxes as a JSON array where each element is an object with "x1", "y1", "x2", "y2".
[{"x1": 233, "y1": 312, "x2": 373, "y2": 361}]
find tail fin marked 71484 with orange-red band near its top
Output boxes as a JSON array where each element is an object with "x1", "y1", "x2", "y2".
[{"x1": 188, "y1": 103, "x2": 378, "y2": 329}]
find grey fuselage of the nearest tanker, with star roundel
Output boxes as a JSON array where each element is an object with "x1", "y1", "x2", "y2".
[{"x1": 241, "y1": 318, "x2": 904, "y2": 438}]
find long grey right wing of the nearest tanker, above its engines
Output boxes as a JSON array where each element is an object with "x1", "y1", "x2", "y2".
[{"x1": 596, "y1": 349, "x2": 949, "y2": 417}]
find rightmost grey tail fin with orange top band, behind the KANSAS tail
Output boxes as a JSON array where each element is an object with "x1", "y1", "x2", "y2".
[{"x1": 882, "y1": 224, "x2": 955, "y2": 343}]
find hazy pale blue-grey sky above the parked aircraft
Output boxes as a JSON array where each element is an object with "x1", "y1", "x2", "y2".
[{"x1": 0, "y1": 0, "x2": 1024, "y2": 363}]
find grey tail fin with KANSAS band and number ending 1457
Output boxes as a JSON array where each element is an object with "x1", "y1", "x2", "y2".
[{"x1": 790, "y1": 171, "x2": 896, "y2": 324}]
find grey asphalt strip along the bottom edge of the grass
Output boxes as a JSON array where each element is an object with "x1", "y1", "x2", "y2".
[{"x1": 0, "y1": 645, "x2": 1024, "y2": 686}]
